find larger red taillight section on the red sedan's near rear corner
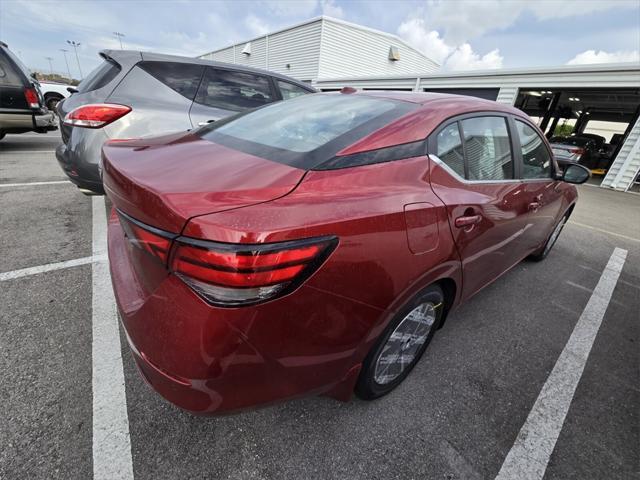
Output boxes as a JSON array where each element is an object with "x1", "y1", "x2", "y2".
[{"x1": 170, "y1": 237, "x2": 338, "y2": 307}]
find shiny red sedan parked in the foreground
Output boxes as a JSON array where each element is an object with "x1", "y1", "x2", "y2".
[{"x1": 103, "y1": 89, "x2": 589, "y2": 413}]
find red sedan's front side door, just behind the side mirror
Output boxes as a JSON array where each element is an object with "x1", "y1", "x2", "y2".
[{"x1": 512, "y1": 118, "x2": 562, "y2": 251}]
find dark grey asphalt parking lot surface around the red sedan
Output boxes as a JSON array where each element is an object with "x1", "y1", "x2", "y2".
[{"x1": 0, "y1": 132, "x2": 640, "y2": 480}]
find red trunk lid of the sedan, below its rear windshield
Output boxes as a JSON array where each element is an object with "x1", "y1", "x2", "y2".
[{"x1": 103, "y1": 133, "x2": 305, "y2": 233}]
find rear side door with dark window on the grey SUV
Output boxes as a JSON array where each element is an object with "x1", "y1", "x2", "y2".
[{"x1": 190, "y1": 67, "x2": 278, "y2": 128}]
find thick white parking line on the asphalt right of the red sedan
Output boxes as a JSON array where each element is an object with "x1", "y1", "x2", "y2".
[{"x1": 496, "y1": 248, "x2": 627, "y2": 480}]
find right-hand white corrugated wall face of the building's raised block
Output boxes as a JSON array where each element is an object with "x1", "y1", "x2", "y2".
[{"x1": 318, "y1": 19, "x2": 438, "y2": 79}]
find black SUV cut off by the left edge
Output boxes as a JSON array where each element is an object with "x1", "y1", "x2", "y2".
[{"x1": 0, "y1": 42, "x2": 57, "y2": 140}]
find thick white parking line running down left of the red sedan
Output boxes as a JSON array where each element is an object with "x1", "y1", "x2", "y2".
[{"x1": 92, "y1": 197, "x2": 133, "y2": 480}]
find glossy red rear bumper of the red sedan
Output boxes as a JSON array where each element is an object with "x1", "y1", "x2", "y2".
[{"x1": 109, "y1": 215, "x2": 381, "y2": 414}]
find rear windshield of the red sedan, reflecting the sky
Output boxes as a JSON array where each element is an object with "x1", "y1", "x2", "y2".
[{"x1": 200, "y1": 94, "x2": 416, "y2": 169}]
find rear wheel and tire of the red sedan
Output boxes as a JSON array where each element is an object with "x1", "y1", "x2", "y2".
[{"x1": 355, "y1": 285, "x2": 444, "y2": 400}]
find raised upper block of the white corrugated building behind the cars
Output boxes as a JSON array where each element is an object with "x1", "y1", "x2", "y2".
[{"x1": 200, "y1": 16, "x2": 439, "y2": 83}]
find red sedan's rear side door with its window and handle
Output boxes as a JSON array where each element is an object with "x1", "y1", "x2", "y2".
[{"x1": 429, "y1": 113, "x2": 528, "y2": 298}]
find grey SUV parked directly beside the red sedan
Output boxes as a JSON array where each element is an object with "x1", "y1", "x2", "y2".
[{"x1": 56, "y1": 50, "x2": 315, "y2": 193}]
